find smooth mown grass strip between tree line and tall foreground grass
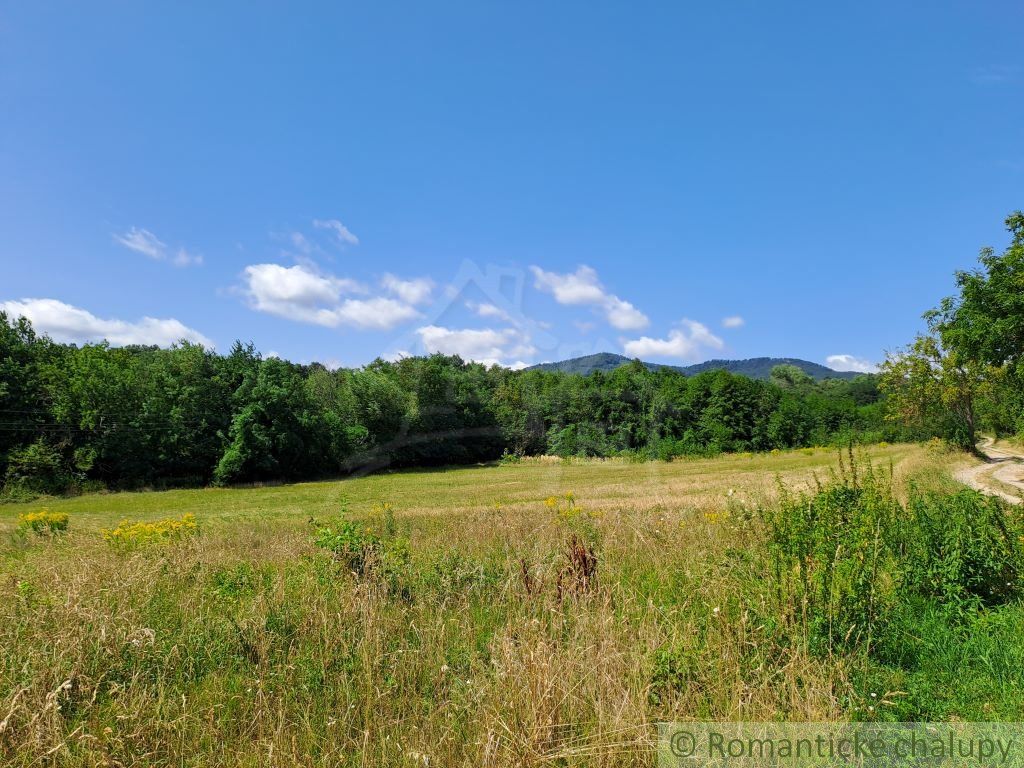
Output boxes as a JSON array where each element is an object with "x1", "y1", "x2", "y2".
[{"x1": 0, "y1": 445, "x2": 923, "y2": 527}]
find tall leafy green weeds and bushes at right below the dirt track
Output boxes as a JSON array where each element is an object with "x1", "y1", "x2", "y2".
[{"x1": 761, "y1": 460, "x2": 1024, "y2": 659}]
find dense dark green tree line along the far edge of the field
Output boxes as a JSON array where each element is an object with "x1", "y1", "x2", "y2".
[{"x1": 0, "y1": 313, "x2": 897, "y2": 496}]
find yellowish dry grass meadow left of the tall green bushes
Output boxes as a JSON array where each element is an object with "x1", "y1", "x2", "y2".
[{"x1": 0, "y1": 445, "x2": 948, "y2": 766}]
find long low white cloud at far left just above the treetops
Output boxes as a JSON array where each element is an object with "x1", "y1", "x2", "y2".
[{"x1": 0, "y1": 299, "x2": 214, "y2": 349}]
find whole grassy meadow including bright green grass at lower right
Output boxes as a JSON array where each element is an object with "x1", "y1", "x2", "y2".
[{"x1": 0, "y1": 445, "x2": 1024, "y2": 766}]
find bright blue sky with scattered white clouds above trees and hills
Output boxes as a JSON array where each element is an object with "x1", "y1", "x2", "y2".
[{"x1": 0, "y1": 0, "x2": 1024, "y2": 368}]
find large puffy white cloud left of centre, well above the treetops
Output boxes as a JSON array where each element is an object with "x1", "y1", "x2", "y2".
[{"x1": 243, "y1": 264, "x2": 420, "y2": 330}]
